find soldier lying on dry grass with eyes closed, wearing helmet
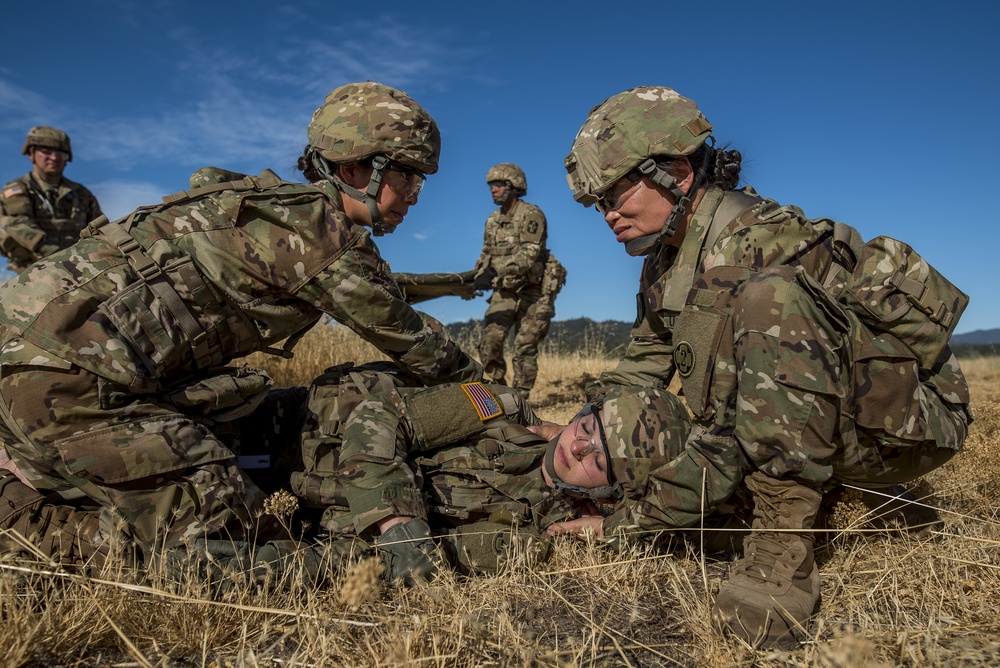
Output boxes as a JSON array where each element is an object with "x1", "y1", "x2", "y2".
[{"x1": 291, "y1": 364, "x2": 689, "y2": 583}]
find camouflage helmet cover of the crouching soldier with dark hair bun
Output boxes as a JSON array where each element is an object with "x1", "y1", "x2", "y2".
[{"x1": 565, "y1": 86, "x2": 712, "y2": 206}]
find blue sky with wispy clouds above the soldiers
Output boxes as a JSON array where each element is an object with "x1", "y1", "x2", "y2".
[{"x1": 0, "y1": 0, "x2": 1000, "y2": 332}]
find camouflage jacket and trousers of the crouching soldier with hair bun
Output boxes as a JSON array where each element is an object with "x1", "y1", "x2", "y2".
[{"x1": 592, "y1": 187, "x2": 971, "y2": 535}]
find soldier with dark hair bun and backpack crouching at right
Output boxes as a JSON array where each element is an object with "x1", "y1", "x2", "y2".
[{"x1": 562, "y1": 86, "x2": 971, "y2": 648}]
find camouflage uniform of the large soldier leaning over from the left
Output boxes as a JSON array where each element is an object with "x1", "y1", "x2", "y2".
[{"x1": 0, "y1": 172, "x2": 481, "y2": 546}]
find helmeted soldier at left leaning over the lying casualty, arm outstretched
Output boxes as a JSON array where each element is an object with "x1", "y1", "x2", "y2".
[{"x1": 0, "y1": 82, "x2": 482, "y2": 576}]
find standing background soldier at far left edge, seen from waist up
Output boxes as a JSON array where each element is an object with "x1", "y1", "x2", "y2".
[{"x1": 0, "y1": 126, "x2": 101, "y2": 273}]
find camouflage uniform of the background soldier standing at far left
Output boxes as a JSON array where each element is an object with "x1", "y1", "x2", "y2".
[{"x1": 0, "y1": 173, "x2": 101, "y2": 273}]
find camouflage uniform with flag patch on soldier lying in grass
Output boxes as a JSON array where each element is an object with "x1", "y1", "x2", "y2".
[{"x1": 292, "y1": 368, "x2": 573, "y2": 538}]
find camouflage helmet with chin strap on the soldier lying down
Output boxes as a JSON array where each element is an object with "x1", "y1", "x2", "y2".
[{"x1": 543, "y1": 386, "x2": 691, "y2": 501}]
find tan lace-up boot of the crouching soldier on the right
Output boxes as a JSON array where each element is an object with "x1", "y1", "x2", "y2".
[{"x1": 712, "y1": 472, "x2": 822, "y2": 650}]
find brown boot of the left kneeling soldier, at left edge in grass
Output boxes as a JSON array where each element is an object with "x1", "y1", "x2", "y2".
[{"x1": 0, "y1": 469, "x2": 109, "y2": 568}]
